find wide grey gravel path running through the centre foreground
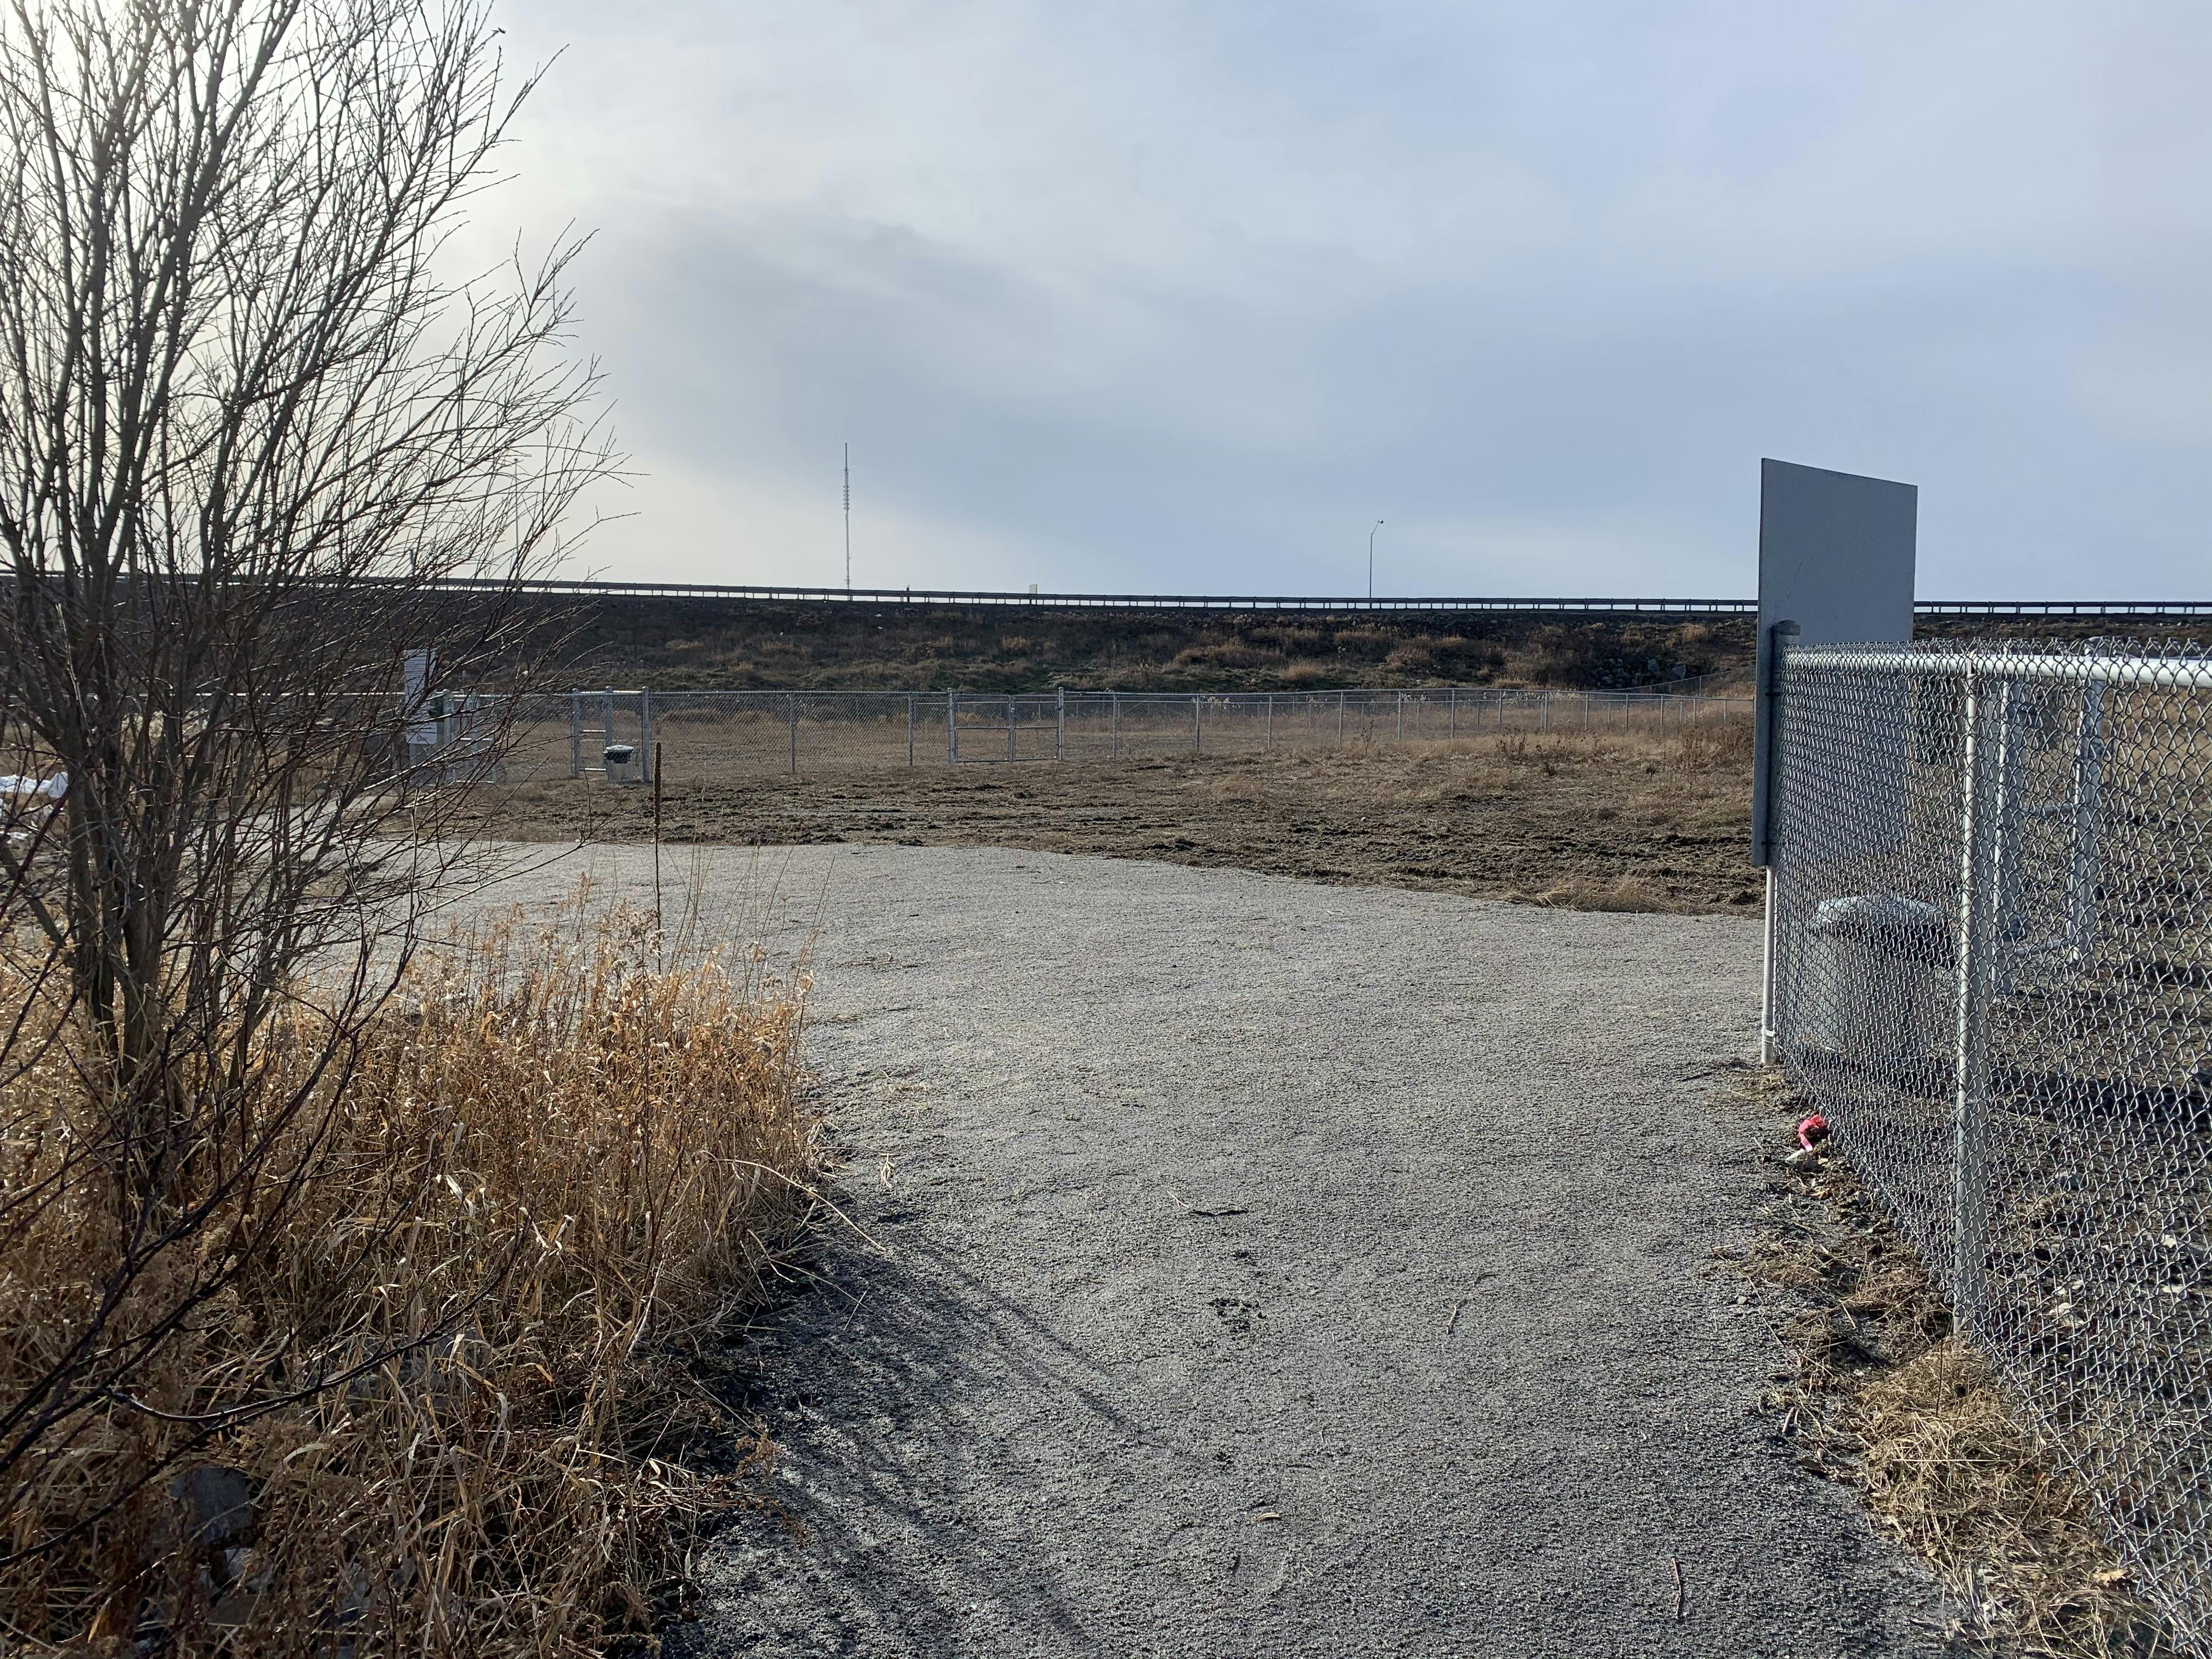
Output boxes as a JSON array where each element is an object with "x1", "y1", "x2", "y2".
[{"x1": 526, "y1": 847, "x2": 1942, "y2": 1659}]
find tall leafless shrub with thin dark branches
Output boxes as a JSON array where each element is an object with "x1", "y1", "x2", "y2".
[{"x1": 0, "y1": 0, "x2": 613, "y2": 1641}]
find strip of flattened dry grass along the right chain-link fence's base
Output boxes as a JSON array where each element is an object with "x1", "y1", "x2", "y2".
[{"x1": 1732, "y1": 1077, "x2": 2176, "y2": 1659}]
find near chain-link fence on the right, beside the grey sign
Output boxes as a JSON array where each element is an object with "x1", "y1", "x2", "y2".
[{"x1": 1774, "y1": 641, "x2": 2212, "y2": 1652}]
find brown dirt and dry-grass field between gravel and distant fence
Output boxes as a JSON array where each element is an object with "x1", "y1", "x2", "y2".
[{"x1": 484, "y1": 712, "x2": 1760, "y2": 913}]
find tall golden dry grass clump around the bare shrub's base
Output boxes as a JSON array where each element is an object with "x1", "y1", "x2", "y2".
[{"x1": 0, "y1": 916, "x2": 821, "y2": 1657}]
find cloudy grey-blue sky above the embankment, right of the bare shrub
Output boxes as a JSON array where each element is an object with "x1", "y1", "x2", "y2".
[{"x1": 480, "y1": 0, "x2": 2212, "y2": 597}]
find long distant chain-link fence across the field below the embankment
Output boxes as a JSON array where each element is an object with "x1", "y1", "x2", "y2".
[{"x1": 506, "y1": 686, "x2": 1750, "y2": 783}]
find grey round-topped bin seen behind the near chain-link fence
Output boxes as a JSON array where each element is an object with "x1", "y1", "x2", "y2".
[{"x1": 1796, "y1": 894, "x2": 1957, "y2": 1082}]
